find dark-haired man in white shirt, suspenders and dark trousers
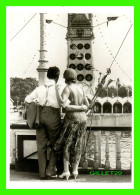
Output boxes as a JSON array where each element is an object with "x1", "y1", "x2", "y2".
[{"x1": 25, "y1": 67, "x2": 85, "y2": 179}]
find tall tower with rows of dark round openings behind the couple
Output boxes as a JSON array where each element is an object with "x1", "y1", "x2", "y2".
[{"x1": 66, "y1": 13, "x2": 94, "y2": 94}]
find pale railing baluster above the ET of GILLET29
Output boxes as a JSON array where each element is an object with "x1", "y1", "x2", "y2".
[{"x1": 105, "y1": 131, "x2": 110, "y2": 169}]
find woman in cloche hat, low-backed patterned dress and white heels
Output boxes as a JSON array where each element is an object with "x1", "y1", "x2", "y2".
[{"x1": 54, "y1": 69, "x2": 89, "y2": 180}]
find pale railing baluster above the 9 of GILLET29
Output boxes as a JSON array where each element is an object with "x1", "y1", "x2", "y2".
[{"x1": 116, "y1": 131, "x2": 121, "y2": 170}]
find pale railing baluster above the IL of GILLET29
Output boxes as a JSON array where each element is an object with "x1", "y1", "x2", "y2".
[{"x1": 94, "y1": 131, "x2": 99, "y2": 169}]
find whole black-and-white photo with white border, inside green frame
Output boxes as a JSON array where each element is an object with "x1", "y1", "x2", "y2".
[{"x1": 6, "y1": 6, "x2": 134, "y2": 189}]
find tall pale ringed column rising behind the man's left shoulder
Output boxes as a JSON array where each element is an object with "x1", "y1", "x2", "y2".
[{"x1": 37, "y1": 13, "x2": 48, "y2": 86}]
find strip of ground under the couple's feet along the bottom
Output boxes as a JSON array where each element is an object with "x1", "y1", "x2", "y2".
[{"x1": 10, "y1": 170, "x2": 131, "y2": 183}]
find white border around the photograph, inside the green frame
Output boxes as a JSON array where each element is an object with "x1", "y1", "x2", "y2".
[{"x1": 6, "y1": 6, "x2": 134, "y2": 189}]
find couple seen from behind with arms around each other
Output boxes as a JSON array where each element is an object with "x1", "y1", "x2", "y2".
[{"x1": 25, "y1": 67, "x2": 89, "y2": 180}]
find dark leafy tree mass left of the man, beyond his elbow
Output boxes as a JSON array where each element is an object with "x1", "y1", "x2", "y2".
[{"x1": 10, "y1": 77, "x2": 38, "y2": 104}]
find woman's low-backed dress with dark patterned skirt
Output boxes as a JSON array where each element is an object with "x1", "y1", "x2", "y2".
[{"x1": 54, "y1": 87, "x2": 86, "y2": 163}]
